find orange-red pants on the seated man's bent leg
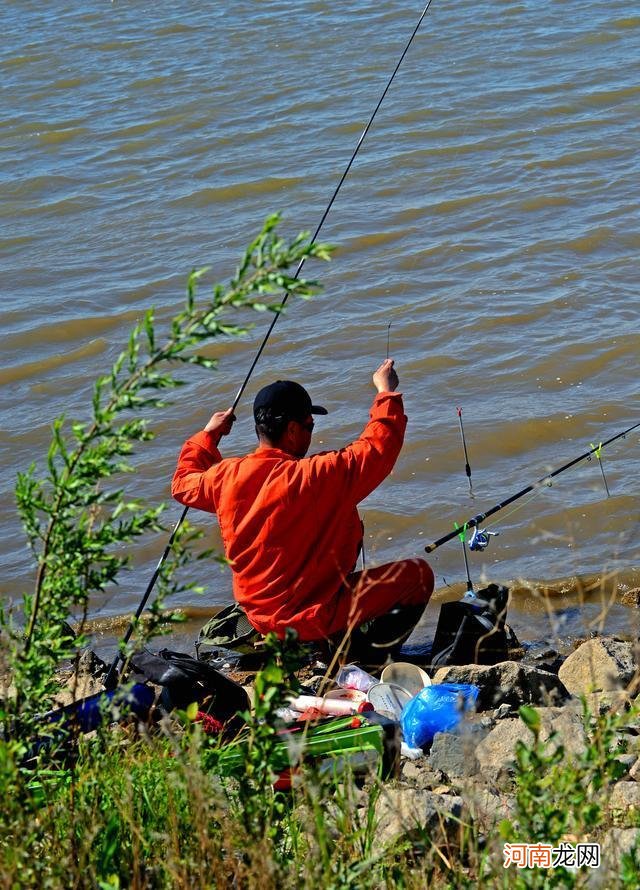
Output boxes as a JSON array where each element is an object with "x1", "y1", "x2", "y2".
[{"x1": 327, "y1": 559, "x2": 434, "y2": 636}]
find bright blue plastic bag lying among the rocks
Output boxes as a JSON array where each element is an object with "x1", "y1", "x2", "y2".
[{"x1": 400, "y1": 683, "x2": 480, "y2": 748}]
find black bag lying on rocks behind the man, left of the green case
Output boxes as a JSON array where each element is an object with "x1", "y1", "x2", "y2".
[{"x1": 130, "y1": 649, "x2": 249, "y2": 723}]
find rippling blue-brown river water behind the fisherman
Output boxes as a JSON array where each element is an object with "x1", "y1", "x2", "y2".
[{"x1": 0, "y1": 0, "x2": 640, "y2": 652}]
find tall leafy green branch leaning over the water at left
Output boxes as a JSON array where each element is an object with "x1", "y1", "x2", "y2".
[{"x1": 2, "y1": 215, "x2": 330, "y2": 714}]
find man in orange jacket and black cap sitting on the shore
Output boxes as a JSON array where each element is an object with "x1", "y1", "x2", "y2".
[{"x1": 171, "y1": 359, "x2": 434, "y2": 648}]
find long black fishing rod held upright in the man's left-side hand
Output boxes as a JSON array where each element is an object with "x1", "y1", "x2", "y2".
[{"x1": 105, "y1": 0, "x2": 433, "y2": 689}]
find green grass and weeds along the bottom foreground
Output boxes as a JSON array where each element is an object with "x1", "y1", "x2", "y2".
[{"x1": 0, "y1": 640, "x2": 640, "y2": 890}]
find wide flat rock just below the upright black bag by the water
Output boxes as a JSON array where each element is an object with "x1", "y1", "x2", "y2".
[{"x1": 433, "y1": 661, "x2": 569, "y2": 711}]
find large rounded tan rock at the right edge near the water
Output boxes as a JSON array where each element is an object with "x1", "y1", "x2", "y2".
[{"x1": 558, "y1": 637, "x2": 638, "y2": 695}]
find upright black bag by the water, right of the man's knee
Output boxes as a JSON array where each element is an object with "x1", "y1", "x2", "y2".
[{"x1": 431, "y1": 584, "x2": 517, "y2": 666}]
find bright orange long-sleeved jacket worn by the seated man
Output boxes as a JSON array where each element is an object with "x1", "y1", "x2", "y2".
[{"x1": 171, "y1": 393, "x2": 407, "y2": 640}]
